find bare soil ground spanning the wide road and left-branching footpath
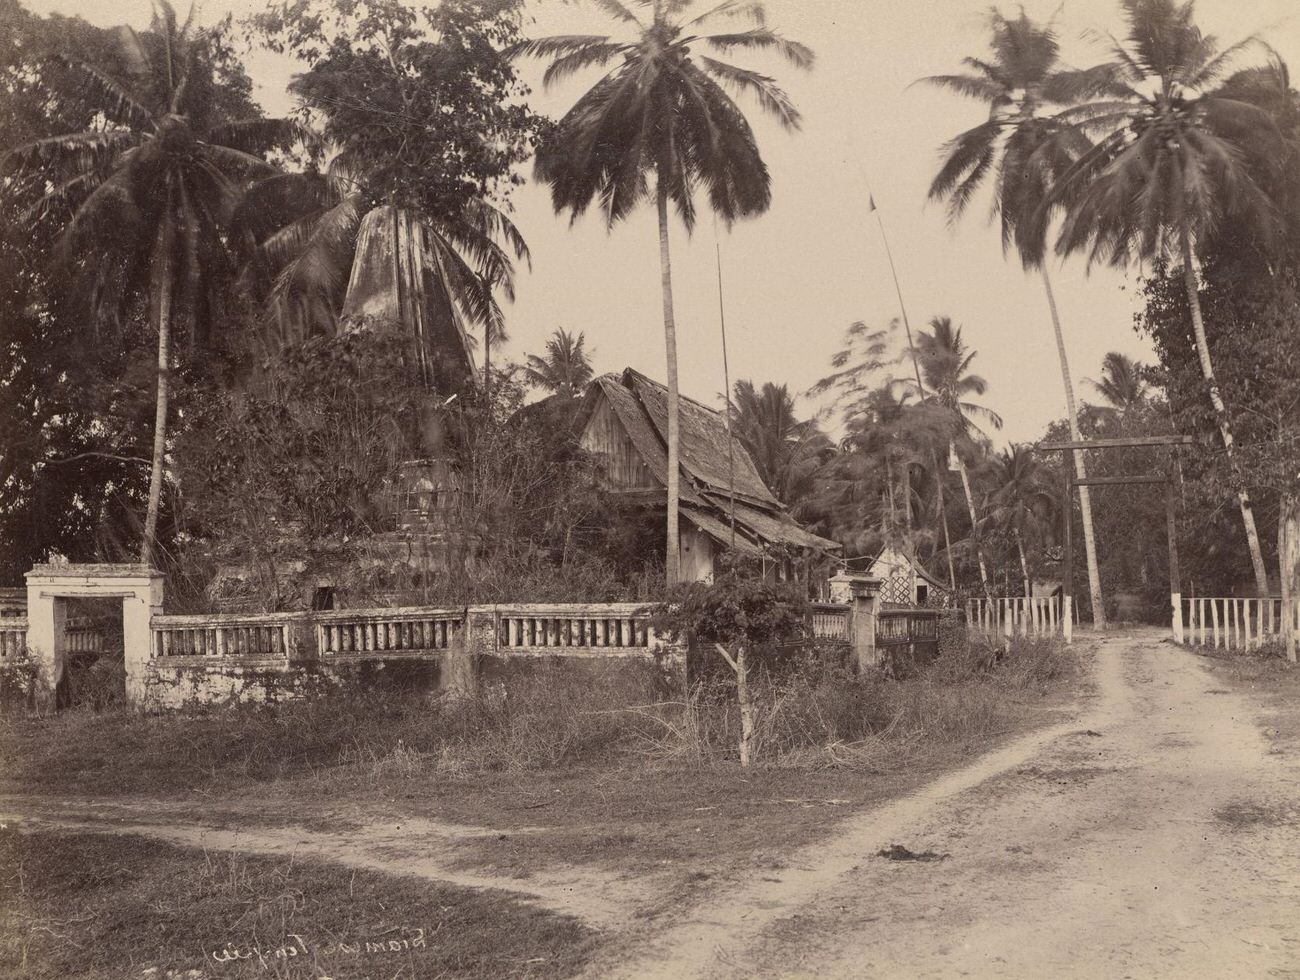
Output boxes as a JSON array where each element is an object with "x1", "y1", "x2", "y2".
[{"x1": 0, "y1": 630, "x2": 1300, "y2": 977}]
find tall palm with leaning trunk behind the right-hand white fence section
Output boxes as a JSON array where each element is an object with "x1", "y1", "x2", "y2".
[{"x1": 1049, "y1": 0, "x2": 1277, "y2": 595}]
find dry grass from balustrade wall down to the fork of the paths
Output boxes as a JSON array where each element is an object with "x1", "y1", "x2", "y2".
[{"x1": 0, "y1": 634, "x2": 1076, "y2": 915}]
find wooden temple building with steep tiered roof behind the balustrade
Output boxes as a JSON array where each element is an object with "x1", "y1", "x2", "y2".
[{"x1": 580, "y1": 368, "x2": 840, "y2": 581}]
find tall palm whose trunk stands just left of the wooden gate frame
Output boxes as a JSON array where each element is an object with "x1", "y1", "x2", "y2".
[{"x1": 922, "y1": 10, "x2": 1105, "y2": 626}]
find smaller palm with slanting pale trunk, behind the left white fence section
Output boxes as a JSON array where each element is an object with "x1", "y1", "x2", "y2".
[{"x1": 905, "y1": 316, "x2": 1002, "y2": 591}]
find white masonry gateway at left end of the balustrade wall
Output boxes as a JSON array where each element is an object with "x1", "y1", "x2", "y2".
[{"x1": 26, "y1": 564, "x2": 163, "y2": 704}]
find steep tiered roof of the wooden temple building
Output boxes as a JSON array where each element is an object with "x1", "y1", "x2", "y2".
[{"x1": 584, "y1": 368, "x2": 840, "y2": 554}]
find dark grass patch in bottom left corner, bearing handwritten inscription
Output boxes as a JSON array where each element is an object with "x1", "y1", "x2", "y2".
[{"x1": 0, "y1": 829, "x2": 594, "y2": 980}]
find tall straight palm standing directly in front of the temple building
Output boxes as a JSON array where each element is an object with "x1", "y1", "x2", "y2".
[{"x1": 517, "y1": 0, "x2": 813, "y2": 584}]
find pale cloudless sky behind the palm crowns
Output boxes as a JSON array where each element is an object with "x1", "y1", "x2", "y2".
[{"x1": 25, "y1": 0, "x2": 1300, "y2": 442}]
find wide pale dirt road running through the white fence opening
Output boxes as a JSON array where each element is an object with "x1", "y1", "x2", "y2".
[{"x1": 590, "y1": 632, "x2": 1300, "y2": 977}]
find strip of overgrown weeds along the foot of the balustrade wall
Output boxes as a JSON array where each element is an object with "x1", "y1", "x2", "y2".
[{"x1": 0, "y1": 641, "x2": 1076, "y2": 794}]
